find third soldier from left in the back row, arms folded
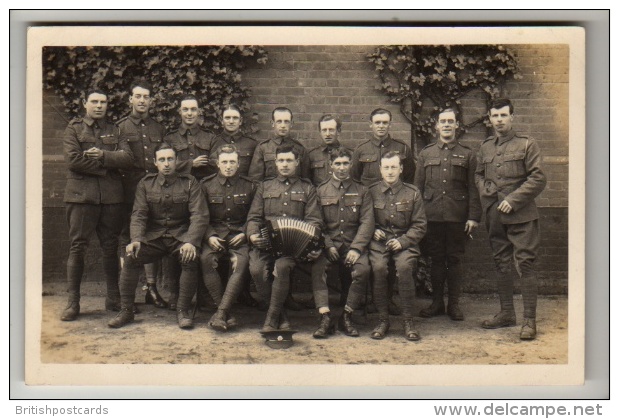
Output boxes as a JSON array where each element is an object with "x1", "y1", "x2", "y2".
[{"x1": 163, "y1": 95, "x2": 217, "y2": 180}]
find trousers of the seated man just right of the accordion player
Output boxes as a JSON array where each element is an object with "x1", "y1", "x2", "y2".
[{"x1": 311, "y1": 246, "x2": 370, "y2": 310}]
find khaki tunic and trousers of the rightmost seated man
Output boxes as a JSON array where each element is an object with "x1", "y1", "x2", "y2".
[{"x1": 370, "y1": 180, "x2": 426, "y2": 319}]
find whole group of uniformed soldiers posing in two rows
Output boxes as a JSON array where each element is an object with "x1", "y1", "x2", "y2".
[{"x1": 61, "y1": 81, "x2": 546, "y2": 341}]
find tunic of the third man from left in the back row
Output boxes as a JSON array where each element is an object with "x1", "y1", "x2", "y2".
[{"x1": 163, "y1": 124, "x2": 217, "y2": 180}]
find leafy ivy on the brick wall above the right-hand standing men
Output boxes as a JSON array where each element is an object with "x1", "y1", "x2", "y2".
[{"x1": 368, "y1": 45, "x2": 520, "y2": 149}]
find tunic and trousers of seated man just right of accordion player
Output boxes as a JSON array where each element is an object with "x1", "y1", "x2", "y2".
[{"x1": 312, "y1": 176, "x2": 374, "y2": 310}]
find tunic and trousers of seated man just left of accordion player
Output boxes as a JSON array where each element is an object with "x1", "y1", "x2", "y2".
[{"x1": 200, "y1": 173, "x2": 257, "y2": 310}]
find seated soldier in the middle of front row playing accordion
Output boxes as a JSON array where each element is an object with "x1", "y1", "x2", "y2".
[{"x1": 247, "y1": 144, "x2": 322, "y2": 332}]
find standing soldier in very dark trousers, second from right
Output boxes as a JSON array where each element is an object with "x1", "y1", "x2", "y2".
[{"x1": 415, "y1": 108, "x2": 481, "y2": 320}]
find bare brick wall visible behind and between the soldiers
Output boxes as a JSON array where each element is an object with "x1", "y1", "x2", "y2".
[{"x1": 43, "y1": 45, "x2": 569, "y2": 293}]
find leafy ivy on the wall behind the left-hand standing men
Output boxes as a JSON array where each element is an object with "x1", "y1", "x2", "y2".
[{"x1": 43, "y1": 46, "x2": 267, "y2": 131}]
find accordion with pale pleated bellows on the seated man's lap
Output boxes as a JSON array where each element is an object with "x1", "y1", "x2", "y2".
[{"x1": 260, "y1": 218, "x2": 323, "y2": 259}]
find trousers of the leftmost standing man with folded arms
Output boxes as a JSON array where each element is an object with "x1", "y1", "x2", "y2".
[{"x1": 65, "y1": 203, "x2": 123, "y2": 301}]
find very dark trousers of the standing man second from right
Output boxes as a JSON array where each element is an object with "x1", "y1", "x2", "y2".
[{"x1": 423, "y1": 221, "x2": 466, "y2": 304}]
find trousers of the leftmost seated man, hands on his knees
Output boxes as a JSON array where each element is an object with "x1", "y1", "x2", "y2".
[{"x1": 120, "y1": 237, "x2": 199, "y2": 310}]
